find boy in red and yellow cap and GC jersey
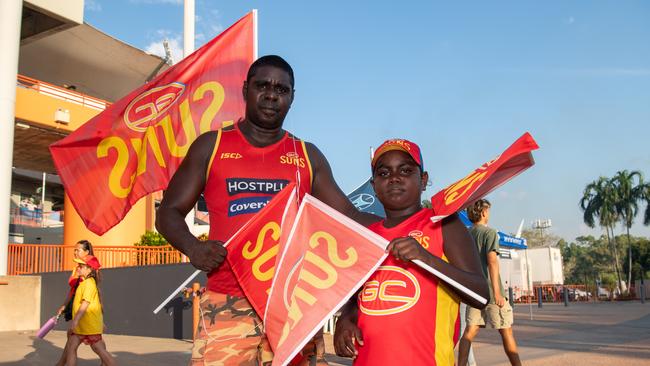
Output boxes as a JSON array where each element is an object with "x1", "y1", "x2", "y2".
[{"x1": 334, "y1": 140, "x2": 488, "y2": 366}]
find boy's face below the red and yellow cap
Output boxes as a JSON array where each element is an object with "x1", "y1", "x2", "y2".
[{"x1": 372, "y1": 150, "x2": 429, "y2": 210}]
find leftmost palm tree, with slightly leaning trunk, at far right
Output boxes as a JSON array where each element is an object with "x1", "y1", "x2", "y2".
[{"x1": 580, "y1": 177, "x2": 621, "y2": 294}]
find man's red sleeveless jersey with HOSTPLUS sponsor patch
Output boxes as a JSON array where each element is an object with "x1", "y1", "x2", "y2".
[{"x1": 203, "y1": 124, "x2": 312, "y2": 296}]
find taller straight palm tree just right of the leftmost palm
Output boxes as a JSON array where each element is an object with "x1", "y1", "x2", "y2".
[{"x1": 612, "y1": 170, "x2": 645, "y2": 293}]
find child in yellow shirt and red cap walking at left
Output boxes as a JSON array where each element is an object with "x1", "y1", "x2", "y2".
[{"x1": 66, "y1": 255, "x2": 115, "y2": 366}]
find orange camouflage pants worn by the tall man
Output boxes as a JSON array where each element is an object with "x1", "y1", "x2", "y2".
[{"x1": 190, "y1": 291, "x2": 327, "y2": 366}]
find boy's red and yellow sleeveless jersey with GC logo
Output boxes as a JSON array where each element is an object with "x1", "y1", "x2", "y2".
[{"x1": 354, "y1": 209, "x2": 460, "y2": 366}]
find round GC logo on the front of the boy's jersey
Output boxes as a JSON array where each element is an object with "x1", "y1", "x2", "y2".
[{"x1": 359, "y1": 266, "x2": 421, "y2": 316}]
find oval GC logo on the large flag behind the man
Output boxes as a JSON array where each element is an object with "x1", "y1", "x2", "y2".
[{"x1": 124, "y1": 82, "x2": 185, "y2": 132}]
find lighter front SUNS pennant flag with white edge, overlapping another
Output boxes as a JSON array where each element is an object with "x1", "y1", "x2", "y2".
[{"x1": 264, "y1": 195, "x2": 388, "y2": 365}]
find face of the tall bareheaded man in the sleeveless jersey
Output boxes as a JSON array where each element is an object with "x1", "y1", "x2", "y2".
[{"x1": 243, "y1": 66, "x2": 293, "y2": 129}]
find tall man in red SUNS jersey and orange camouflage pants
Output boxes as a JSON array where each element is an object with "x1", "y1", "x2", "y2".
[{"x1": 156, "y1": 56, "x2": 378, "y2": 365}]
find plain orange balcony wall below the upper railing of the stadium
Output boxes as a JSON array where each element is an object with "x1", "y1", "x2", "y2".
[{"x1": 16, "y1": 87, "x2": 101, "y2": 132}]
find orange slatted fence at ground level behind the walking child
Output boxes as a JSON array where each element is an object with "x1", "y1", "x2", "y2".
[{"x1": 7, "y1": 244, "x2": 188, "y2": 275}]
